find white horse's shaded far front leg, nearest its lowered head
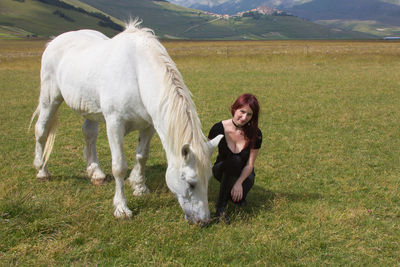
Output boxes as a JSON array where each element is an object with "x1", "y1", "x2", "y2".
[{"x1": 129, "y1": 127, "x2": 155, "y2": 196}]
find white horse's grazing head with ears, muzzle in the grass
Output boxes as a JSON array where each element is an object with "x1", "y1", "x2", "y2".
[{"x1": 166, "y1": 135, "x2": 223, "y2": 223}]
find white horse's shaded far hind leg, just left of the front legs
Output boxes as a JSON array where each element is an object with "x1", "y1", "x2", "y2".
[{"x1": 82, "y1": 119, "x2": 106, "y2": 185}]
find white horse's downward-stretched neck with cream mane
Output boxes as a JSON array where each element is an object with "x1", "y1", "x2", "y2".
[{"x1": 131, "y1": 34, "x2": 198, "y2": 163}]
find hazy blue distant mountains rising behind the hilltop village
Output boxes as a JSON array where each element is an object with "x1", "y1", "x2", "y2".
[{"x1": 170, "y1": 0, "x2": 400, "y2": 36}]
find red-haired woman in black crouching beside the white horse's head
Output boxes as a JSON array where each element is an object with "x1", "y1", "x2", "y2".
[{"x1": 208, "y1": 94, "x2": 262, "y2": 223}]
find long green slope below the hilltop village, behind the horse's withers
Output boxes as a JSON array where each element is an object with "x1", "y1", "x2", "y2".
[{"x1": 77, "y1": 0, "x2": 373, "y2": 39}]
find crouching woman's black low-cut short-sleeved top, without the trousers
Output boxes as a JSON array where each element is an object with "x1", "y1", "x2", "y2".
[{"x1": 208, "y1": 121, "x2": 262, "y2": 163}]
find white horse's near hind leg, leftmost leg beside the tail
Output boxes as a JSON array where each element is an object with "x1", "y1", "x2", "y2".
[{"x1": 33, "y1": 100, "x2": 62, "y2": 180}]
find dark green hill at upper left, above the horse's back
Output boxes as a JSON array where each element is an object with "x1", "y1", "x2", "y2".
[{"x1": 0, "y1": 0, "x2": 122, "y2": 38}]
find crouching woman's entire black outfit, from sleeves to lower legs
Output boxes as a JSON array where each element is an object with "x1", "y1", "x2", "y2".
[{"x1": 208, "y1": 121, "x2": 262, "y2": 207}]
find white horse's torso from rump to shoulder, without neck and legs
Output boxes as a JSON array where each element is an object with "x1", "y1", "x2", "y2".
[{"x1": 42, "y1": 30, "x2": 154, "y2": 126}]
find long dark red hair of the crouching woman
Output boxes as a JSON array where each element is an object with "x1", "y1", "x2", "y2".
[{"x1": 231, "y1": 94, "x2": 260, "y2": 148}]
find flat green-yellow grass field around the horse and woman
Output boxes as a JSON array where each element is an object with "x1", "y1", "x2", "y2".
[{"x1": 0, "y1": 41, "x2": 400, "y2": 266}]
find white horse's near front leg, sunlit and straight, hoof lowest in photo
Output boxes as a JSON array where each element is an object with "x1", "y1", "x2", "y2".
[{"x1": 106, "y1": 116, "x2": 132, "y2": 218}]
